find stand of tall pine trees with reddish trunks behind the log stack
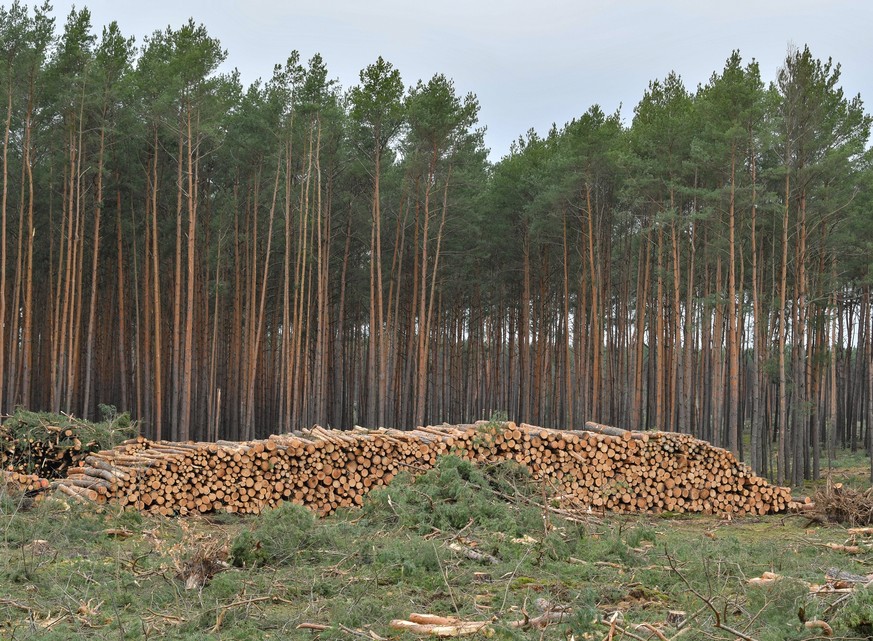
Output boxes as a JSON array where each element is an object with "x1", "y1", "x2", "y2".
[{"x1": 0, "y1": 2, "x2": 873, "y2": 483}]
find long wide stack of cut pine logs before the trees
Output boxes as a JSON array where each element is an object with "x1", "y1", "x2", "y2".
[{"x1": 55, "y1": 422, "x2": 791, "y2": 515}]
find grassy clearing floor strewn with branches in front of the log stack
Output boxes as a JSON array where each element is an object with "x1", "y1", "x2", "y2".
[{"x1": 0, "y1": 456, "x2": 873, "y2": 641}]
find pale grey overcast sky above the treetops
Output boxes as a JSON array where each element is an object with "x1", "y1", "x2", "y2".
[{"x1": 42, "y1": 0, "x2": 873, "y2": 161}]
